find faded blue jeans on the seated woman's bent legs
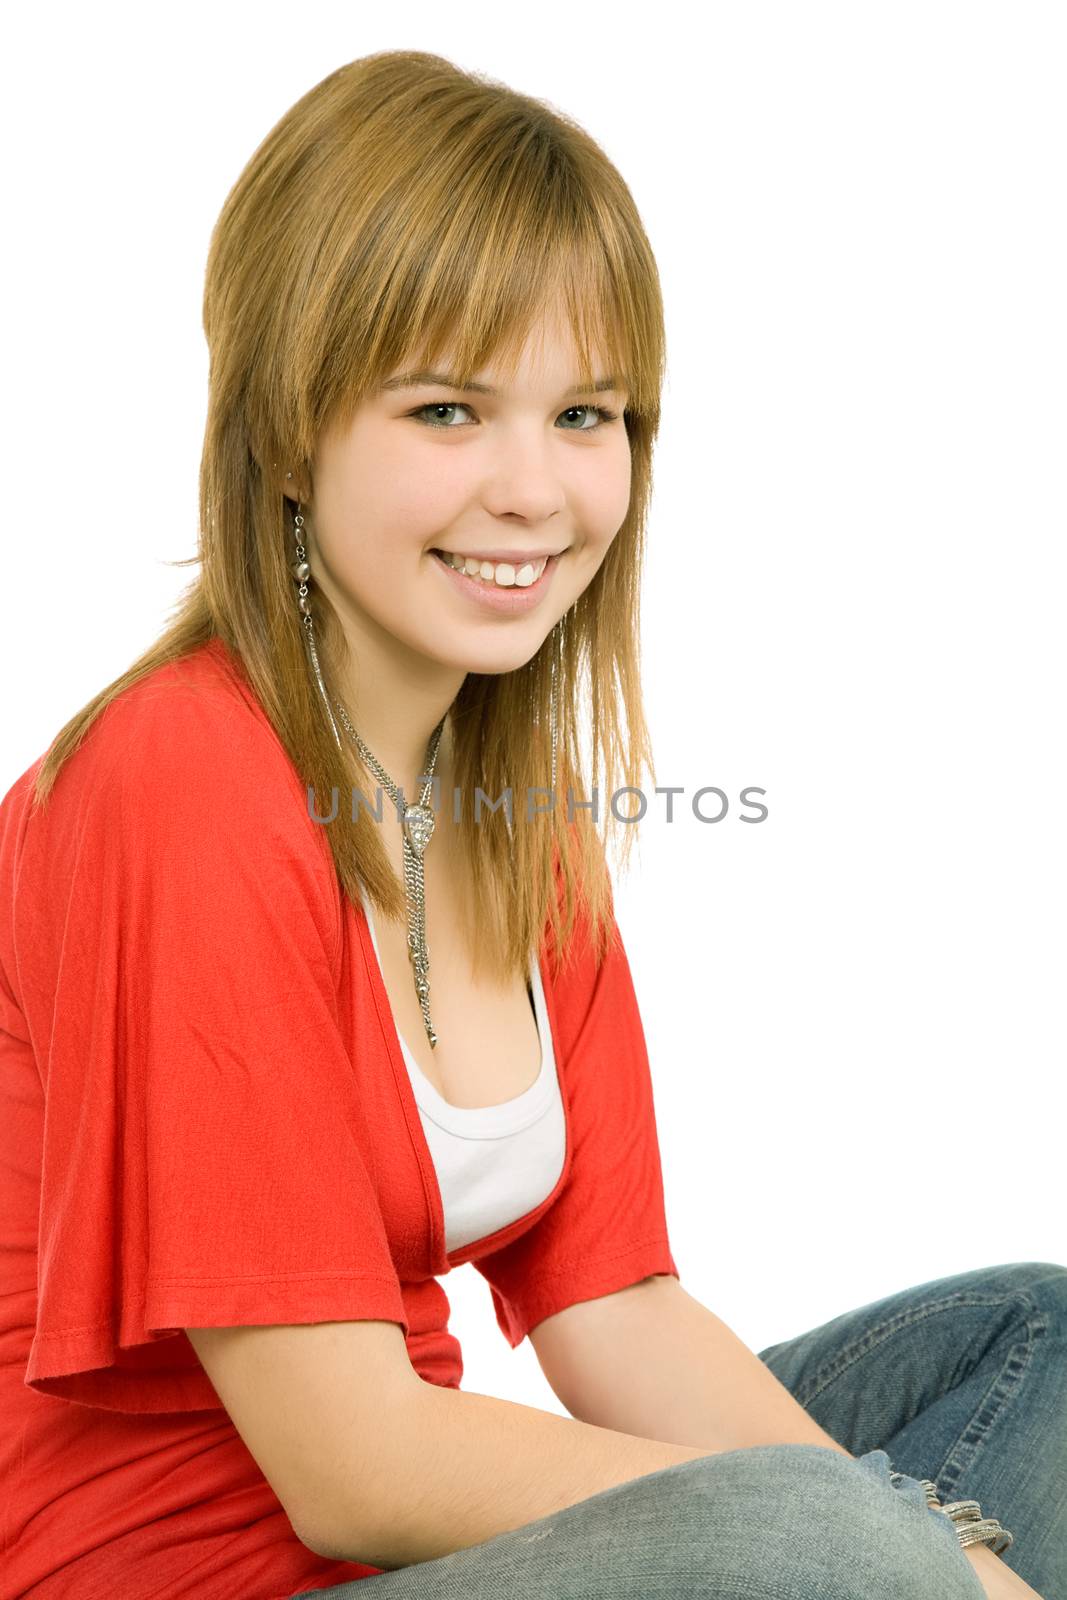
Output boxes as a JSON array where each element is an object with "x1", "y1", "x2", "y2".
[{"x1": 292, "y1": 1262, "x2": 1067, "y2": 1600}]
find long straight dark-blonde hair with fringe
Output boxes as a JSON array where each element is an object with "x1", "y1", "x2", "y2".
[{"x1": 35, "y1": 50, "x2": 665, "y2": 979}]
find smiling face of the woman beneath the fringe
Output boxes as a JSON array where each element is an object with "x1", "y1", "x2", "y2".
[{"x1": 307, "y1": 300, "x2": 630, "y2": 686}]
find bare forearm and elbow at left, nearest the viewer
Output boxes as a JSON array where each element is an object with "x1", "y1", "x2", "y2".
[{"x1": 187, "y1": 1320, "x2": 713, "y2": 1568}]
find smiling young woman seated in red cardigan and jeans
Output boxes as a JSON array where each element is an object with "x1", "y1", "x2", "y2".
[{"x1": 0, "y1": 51, "x2": 1067, "y2": 1600}]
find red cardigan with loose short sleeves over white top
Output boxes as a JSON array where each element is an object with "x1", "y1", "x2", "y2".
[{"x1": 0, "y1": 640, "x2": 678, "y2": 1600}]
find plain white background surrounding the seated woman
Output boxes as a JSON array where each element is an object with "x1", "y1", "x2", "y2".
[{"x1": 0, "y1": 0, "x2": 1067, "y2": 1411}]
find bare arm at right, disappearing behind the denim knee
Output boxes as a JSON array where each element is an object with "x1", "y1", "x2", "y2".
[{"x1": 530, "y1": 1275, "x2": 1033, "y2": 1600}]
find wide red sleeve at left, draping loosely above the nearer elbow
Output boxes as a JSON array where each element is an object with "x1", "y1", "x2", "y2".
[{"x1": 19, "y1": 682, "x2": 408, "y2": 1411}]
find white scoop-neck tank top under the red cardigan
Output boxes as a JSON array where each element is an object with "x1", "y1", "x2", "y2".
[{"x1": 362, "y1": 893, "x2": 566, "y2": 1253}]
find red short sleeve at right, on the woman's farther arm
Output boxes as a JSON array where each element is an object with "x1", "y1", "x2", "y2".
[{"x1": 474, "y1": 889, "x2": 680, "y2": 1347}]
